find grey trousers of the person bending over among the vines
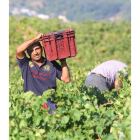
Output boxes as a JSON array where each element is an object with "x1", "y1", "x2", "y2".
[{"x1": 85, "y1": 74, "x2": 109, "y2": 92}]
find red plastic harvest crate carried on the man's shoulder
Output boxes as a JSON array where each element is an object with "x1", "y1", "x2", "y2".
[{"x1": 42, "y1": 29, "x2": 77, "y2": 61}]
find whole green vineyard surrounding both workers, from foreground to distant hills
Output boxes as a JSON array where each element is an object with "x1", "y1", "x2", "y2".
[{"x1": 9, "y1": 17, "x2": 131, "y2": 140}]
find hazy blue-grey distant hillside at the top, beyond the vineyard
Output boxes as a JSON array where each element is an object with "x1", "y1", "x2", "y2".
[{"x1": 9, "y1": 0, "x2": 131, "y2": 21}]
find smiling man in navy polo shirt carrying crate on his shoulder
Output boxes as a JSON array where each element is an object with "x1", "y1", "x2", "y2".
[{"x1": 16, "y1": 33, "x2": 70, "y2": 114}]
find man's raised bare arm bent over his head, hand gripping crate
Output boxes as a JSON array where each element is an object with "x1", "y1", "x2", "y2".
[{"x1": 16, "y1": 33, "x2": 43, "y2": 59}]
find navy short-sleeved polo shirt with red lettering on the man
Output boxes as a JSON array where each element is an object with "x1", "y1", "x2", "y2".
[{"x1": 17, "y1": 56, "x2": 62, "y2": 96}]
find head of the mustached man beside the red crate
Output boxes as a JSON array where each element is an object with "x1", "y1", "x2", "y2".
[{"x1": 27, "y1": 42, "x2": 43, "y2": 61}]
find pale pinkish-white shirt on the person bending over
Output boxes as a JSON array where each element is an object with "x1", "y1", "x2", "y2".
[{"x1": 88, "y1": 60, "x2": 128, "y2": 89}]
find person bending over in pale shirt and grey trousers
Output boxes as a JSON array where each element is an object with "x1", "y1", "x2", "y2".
[{"x1": 85, "y1": 60, "x2": 128, "y2": 91}]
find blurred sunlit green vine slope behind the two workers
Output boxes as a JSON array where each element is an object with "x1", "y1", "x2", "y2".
[{"x1": 9, "y1": 17, "x2": 131, "y2": 72}]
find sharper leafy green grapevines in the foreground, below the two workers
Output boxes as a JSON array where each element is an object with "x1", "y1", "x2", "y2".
[{"x1": 9, "y1": 67, "x2": 131, "y2": 140}]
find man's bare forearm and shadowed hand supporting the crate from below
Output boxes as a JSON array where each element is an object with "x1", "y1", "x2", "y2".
[{"x1": 60, "y1": 59, "x2": 70, "y2": 83}]
